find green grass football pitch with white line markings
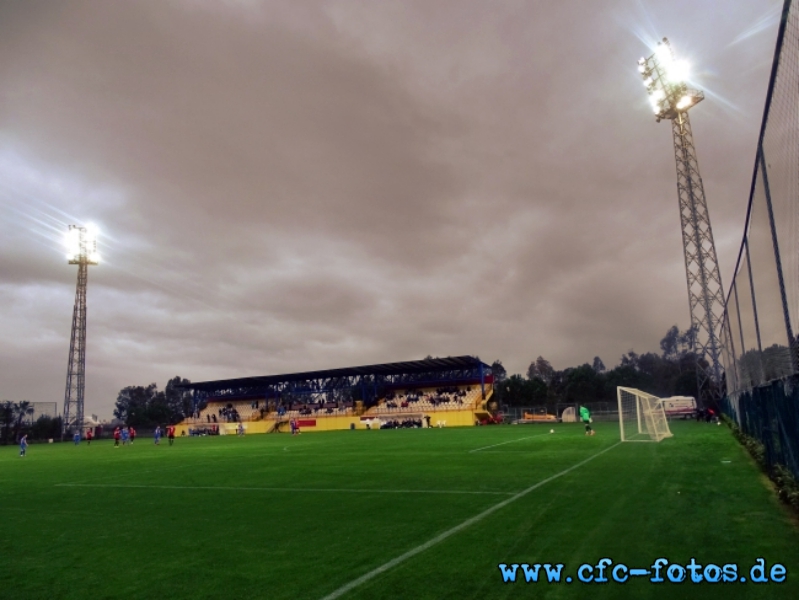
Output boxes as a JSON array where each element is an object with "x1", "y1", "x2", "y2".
[{"x1": 0, "y1": 422, "x2": 799, "y2": 600}]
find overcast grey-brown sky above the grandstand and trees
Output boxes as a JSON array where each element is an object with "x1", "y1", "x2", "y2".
[{"x1": 0, "y1": 0, "x2": 782, "y2": 418}]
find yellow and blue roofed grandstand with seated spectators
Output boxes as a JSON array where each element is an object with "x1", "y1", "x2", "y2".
[{"x1": 178, "y1": 356, "x2": 494, "y2": 435}]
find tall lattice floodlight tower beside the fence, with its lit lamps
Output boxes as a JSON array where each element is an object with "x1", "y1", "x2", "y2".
[{"x1": 638, "y1": 38, "x2": 724, "y2": 401}]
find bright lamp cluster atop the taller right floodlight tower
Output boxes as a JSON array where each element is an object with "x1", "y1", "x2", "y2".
[{"x1": 638, "y1": 38, "x2": 705, "y2": 122}]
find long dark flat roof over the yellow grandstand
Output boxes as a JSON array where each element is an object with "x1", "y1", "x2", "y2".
[{"x1": 180, "y1": 356, "x2": 491, "y2": 392}]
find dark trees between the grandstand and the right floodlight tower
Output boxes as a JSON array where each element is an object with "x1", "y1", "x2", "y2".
[{"x1": 491, "y1": 325, "x2": 698, "y2": 412}]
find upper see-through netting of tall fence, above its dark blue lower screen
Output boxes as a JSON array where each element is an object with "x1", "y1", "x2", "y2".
[{"x1": 721, "y1": 0, "x2": 799, "y2": 395}]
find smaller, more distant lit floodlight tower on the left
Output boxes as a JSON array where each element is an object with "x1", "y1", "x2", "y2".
[{"x1": 61, "y1": 225, "x2": 100, "y2": 438}]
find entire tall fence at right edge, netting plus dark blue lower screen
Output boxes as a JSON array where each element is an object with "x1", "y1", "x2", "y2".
[{"x1": 721, "y1": 0, "x2": 799, "y2": 477}]
